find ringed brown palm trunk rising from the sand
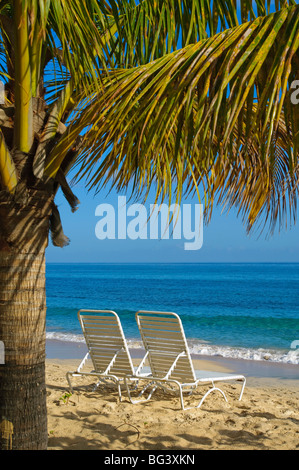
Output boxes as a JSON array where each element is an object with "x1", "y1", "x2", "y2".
[{"x1": 0, "y1": 185, "x2": 53, "y2": 450}]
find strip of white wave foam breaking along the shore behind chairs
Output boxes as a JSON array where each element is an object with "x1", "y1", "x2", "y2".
[{"x1": 46, "y1": 332, "x2": 299, "y2": 365}]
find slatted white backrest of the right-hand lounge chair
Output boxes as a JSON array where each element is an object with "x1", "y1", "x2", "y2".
[{"x1": 136, "y1": 311, "x2": 196, "y2": 383}]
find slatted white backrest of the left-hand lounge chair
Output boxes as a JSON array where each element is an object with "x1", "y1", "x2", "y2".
[{"x1": 78, "y1": 310, "x2": 134, "y2": 377}]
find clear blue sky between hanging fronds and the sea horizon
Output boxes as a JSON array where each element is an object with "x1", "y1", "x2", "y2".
[{"x1": 46, "y1": 184, "x2": 299, "y2": 263}]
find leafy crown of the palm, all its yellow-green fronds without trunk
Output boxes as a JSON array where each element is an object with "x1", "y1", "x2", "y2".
[{"x1": 0, "y1": 0, "x2": 299, "y2": 235}]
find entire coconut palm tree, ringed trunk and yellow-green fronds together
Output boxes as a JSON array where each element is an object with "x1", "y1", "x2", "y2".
[{"x1": 0, "y1": 0, "x2": 299, "y2": 449}]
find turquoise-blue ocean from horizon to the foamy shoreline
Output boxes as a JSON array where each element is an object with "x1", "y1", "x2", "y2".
[{"x1": 46, "y1": 263, "x2": 299, "y2": 364}]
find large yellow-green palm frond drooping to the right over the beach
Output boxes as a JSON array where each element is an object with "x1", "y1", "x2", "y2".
[{"x1": 61, "y1": 6, "x2": 299, "y2": 228}]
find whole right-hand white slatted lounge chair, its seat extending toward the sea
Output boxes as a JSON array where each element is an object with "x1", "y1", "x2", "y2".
[{"x1": 125, "y1": 311, "x2": 246, "y2": 410}]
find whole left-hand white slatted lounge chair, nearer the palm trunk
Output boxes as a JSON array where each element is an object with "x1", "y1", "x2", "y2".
[{"x1": 66, "y1": 310, "x2": 149, "y2": 401}]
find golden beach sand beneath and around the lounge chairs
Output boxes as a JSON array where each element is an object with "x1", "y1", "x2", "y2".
[{"x1": 46, "y1": 344, "x2": 299, "y2": 452}]
